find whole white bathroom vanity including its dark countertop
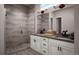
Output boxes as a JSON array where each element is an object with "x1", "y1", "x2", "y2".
[{"x1": 30, "y1": 34, "x2": 74, "y2": 55}]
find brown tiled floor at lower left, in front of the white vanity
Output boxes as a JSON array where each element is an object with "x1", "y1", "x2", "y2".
[{"x1": 6, "y1": 44, "x2": 40, "y2": 55}]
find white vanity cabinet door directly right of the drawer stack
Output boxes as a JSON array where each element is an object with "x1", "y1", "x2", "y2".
[{"x1": 49, "y1": 39, "x2": 59, "y2": 55}]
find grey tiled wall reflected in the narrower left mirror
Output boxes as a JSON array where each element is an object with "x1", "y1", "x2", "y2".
[{"x1": 37, "y1": 13, "x2": 49, "y2": 33}]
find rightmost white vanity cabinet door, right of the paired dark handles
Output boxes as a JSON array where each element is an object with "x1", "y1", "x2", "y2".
[{"x1": 59, "y1": 41, "x2": 74, "y2": 55}]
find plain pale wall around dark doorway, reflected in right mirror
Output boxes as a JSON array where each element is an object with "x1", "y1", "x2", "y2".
[{"x1": 52, "y1": 7, "x2": 74, "y2": 33}]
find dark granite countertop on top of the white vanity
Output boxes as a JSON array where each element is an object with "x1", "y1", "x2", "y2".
[{"x1": 32, "y1": 34, "x2": 74, "y2": 43}]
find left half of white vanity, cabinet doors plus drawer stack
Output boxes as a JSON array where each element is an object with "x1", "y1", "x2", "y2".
[{"x1": 30, "y1": 35, "x2": 48, "y2": 54}]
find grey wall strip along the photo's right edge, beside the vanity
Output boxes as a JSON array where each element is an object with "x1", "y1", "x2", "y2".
[{"x1": 74, "y1": 5, "x2": 79, "y2": 54}]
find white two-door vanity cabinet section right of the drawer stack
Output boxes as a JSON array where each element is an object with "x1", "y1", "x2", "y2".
[{"x1": 49, "y1": 39, "x2": 74, "y2": 55}]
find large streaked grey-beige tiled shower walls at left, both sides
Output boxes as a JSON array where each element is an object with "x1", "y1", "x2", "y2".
[{"x1": 5, "y1": 5, "x2": 34, "y2": 47}]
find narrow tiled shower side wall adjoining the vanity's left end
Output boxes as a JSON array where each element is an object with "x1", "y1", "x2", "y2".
[{"x1": 28, "y1": 7, "x2": 35, "y2": 42}]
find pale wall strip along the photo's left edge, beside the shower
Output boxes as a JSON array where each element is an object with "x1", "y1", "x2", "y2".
[{"x1": 0, "y1": 4, "x2": 5, "y2": 54}]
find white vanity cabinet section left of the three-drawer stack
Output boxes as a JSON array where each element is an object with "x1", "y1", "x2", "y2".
[{"x1": 30, "y1": 35, "x2": 41, "y2": 52}]
